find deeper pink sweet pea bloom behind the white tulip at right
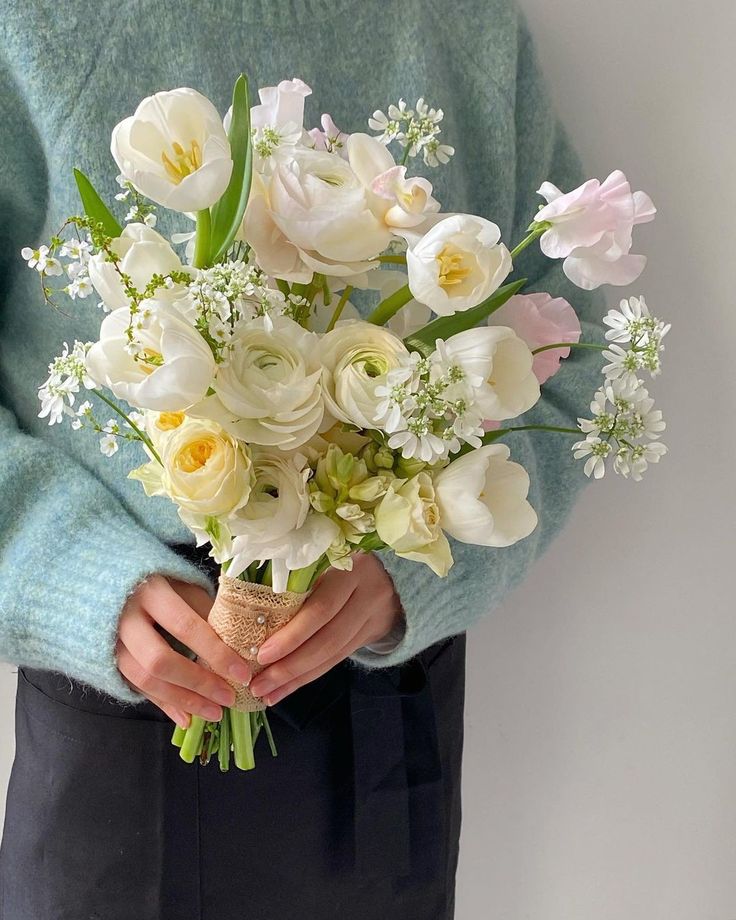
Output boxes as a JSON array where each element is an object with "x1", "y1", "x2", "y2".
[{"x1": 486, "y1": 293, "x2": 581, "y2": 382}]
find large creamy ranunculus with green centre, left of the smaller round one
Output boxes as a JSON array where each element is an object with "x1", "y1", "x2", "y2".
[{"x1": 192, "y1": 316, "x2": 324, "y2": 450}]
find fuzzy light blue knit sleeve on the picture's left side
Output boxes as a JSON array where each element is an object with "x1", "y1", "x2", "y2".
[{"x1": 0, "y1": 61, "x2": 216, "y2": 702}]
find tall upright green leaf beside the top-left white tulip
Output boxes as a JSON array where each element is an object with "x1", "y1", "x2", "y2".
[{"x1": 210, "y1": 74, "x2": 253, "y2": 262}]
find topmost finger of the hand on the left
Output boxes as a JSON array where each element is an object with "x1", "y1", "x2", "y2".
[{"x1": 144, "y1": 579, "x2": 251, "y2": 684}]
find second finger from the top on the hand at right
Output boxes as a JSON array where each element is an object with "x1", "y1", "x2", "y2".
[{"x1": 250, "y1": 595, "x2": 371, "y2": 698}]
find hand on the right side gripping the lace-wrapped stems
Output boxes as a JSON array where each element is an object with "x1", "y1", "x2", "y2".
[{"x1": 250, "y1": 553, "x2": 402, "y2": 706}]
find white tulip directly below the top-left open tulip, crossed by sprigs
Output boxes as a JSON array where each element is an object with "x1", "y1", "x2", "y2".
[{"x1": 88, "y1": 224, "x2": 185, "y2": 310}]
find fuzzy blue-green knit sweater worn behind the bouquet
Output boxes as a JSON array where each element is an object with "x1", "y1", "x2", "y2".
[{"x1": 0, "y1": 0, "x2": 601, "y2": 701}]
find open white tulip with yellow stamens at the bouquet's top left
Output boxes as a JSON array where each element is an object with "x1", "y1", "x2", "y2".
[{"x1": 110, "y1": 87, "x2": 233, "y2": 212}]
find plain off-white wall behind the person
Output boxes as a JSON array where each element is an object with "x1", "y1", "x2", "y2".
[{"x1": 0, "y1": 0, "x2": 736, "y2": 920}]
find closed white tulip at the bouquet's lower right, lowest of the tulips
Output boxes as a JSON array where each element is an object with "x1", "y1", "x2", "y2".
[{"x1": 434, "y1": 444, "x2": 537, "y2": 546}]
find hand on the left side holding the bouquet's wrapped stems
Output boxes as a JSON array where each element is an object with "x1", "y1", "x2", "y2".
[{"x1": 116, "y1": 575, "x2": 251, "y2": 728}]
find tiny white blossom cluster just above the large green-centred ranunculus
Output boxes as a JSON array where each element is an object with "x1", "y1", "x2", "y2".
[{"x1": 188, "y1": 260, "x2": 288, "y2": 354}]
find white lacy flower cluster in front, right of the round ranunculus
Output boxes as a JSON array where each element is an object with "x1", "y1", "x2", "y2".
[{"x1": 375, "y1": 340, "x2": 484, "y2": 463}]
